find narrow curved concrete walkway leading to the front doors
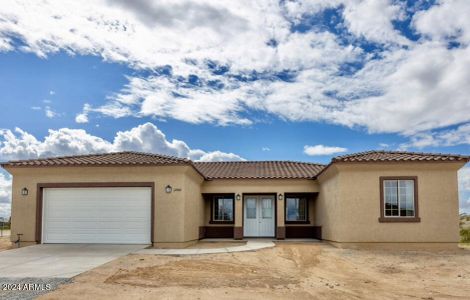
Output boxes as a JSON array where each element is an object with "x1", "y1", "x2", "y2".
[{"x1": 134, "y1": 240, "x2": 275, "y2": 255}]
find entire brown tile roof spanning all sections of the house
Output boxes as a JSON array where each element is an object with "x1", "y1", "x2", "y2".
[{"x1": 1, "y1": 151, "x2": 470, "y2": 180}]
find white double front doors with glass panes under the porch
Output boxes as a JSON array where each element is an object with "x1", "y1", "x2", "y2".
[{"x1": 243, "y1": 195, "x2": 275, "y2": 237}]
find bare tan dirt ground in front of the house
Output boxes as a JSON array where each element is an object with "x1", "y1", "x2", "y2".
[{"x1": 41, "y1": 243, "x2": 470, "y2": 300}]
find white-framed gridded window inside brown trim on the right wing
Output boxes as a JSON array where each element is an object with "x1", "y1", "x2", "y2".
[{"x1": 382, "y1": 179, "x2": 416, "y2": 218}]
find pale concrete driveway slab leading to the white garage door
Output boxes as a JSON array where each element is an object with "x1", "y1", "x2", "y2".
[{"x1": 0, "y1": 244, "x2": 148, "y2": 276}]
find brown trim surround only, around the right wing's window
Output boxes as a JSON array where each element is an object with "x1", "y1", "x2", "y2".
[{"x1": 379, "y1": 176, "x2": 421, "y2": 223}]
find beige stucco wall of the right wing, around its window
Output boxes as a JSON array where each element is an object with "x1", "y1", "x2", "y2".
[{"x1": 316, "y1": 163, "x2": 463, "y2": 243}]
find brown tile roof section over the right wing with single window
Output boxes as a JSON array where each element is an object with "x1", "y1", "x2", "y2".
[{"x1": 331, "y1": 151, "x2": 470, "y2": 163}]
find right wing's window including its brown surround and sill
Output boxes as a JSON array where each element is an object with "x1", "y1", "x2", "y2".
[{"x1": 379, "y1": 177, "x2": 419, "y2": 222}]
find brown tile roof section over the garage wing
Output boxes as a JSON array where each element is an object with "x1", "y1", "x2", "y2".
[{"x1": 2, "y1": 151, "x2": 192, "y2": 167}]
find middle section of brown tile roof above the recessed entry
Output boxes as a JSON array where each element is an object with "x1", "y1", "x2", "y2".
[{"x1": 194, "y1": 161, "x2": 325, "y2": 180}]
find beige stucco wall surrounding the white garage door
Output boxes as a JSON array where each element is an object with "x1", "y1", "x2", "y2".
[{"x1": 8, "y1": 166, "x2": 203, "y2": 243}]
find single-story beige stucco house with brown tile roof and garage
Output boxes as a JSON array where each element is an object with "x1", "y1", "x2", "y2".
[{"x1": 2, "y1": 151, "x2": 469, "y2": 247}]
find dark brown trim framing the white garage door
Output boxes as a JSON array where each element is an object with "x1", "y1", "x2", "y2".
[{"x1": 36, "y1": 182, "x2": 155, "y2": 244}]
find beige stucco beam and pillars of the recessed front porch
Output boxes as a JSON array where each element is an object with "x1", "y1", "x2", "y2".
[{"x1": 201, "y1": 179, "x2": 319, "y2": 227}]
